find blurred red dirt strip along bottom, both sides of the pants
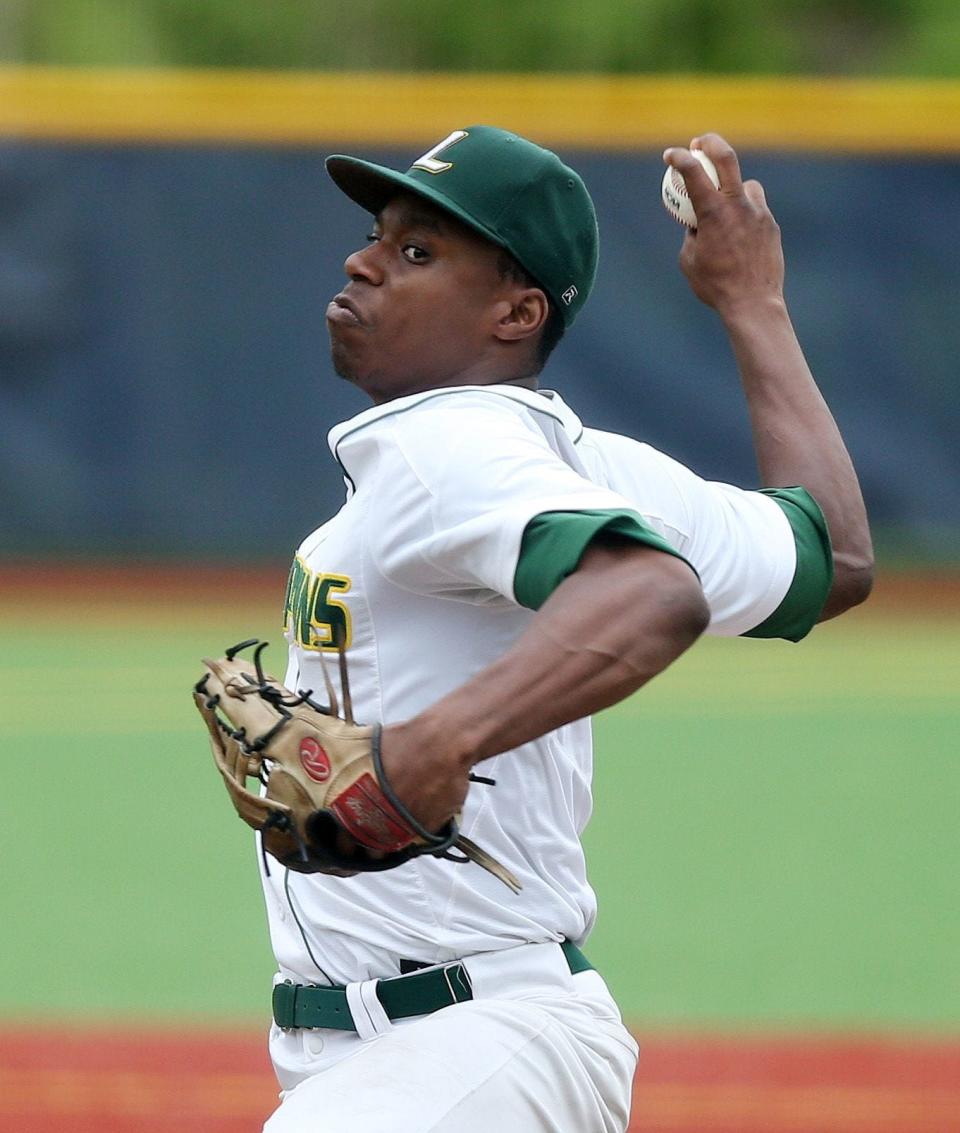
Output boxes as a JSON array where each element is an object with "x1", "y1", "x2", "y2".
[{"x1": 0, "y1": 1026, "x2": 960, "y2": 1133}]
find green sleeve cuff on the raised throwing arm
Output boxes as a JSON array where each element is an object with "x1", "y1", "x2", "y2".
[{"x1": 742, "y1": 487, "x2": 833, "y2": 641}]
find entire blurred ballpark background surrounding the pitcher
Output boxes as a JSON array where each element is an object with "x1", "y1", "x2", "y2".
[{"x1": 0, "y1": 0, "x2": 960, "y2": 1133}]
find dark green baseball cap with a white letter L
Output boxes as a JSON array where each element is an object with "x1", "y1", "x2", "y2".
[{"x1": 326, "y1": 126, "x2": 600, "y2": 326}]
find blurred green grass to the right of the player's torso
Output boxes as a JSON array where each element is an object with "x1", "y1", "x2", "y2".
[{"x1": 587, "y1": 615, "x2": 960, "y2": 1031}]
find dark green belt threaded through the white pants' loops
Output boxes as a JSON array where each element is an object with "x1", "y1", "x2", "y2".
[{"x1": 273, "y1": 940, "x2": 593, "y2": 1031}]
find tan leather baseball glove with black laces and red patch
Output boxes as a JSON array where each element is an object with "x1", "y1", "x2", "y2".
[{"x1": 194, "y1": 639, "x2": 520, "y2": 893}]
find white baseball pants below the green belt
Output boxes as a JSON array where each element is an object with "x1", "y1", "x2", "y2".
[{"x1": 264, "y1": 944, "x2": 638, "y2": 1133}]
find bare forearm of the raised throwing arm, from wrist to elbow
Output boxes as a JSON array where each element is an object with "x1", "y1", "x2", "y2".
[{"x1": 720, "y1": 296, "x2": 873, "y2": 617}]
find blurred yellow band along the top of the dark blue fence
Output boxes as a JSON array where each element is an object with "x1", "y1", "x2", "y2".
[{"x1": 0, "y1": 67, "x2": 960, "y2": 154}]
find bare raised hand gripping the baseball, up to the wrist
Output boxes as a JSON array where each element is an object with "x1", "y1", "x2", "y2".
[{"x1": 663, "y1": 134, "x2": 783, "y2": 316}]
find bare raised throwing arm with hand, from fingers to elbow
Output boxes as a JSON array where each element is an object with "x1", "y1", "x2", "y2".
[{"x1": 663, "y1": 134, "x2": 873, "y2": 621}]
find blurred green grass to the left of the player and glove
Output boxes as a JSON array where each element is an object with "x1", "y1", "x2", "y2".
[{"x1": 0, "y1": 607, "x2": 284, "y2": 1017}]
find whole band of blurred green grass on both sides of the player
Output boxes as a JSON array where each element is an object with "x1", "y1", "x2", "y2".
[{"x1": 0, "y1": 607, "x2": 960, "y2": 1032}]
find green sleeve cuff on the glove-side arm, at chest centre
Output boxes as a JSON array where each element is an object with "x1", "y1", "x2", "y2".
[{"x1": 513, "y1": 508, "x2": 693, "y2": 610}]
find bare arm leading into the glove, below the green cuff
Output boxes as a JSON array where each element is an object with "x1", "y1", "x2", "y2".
[{"x1": 383, "y1": 545, "x2": 710, "y2": 824}]
